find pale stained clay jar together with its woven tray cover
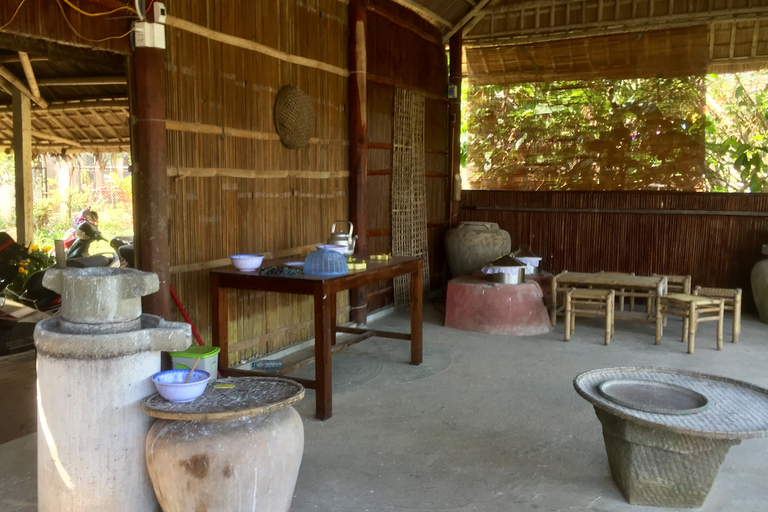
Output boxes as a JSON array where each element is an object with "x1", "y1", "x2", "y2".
[{"x1": 142, "y1": 377, "x2": 304, "y2": 512}]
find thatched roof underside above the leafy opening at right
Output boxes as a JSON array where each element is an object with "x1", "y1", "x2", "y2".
[{"x1": 395, "y1": 0, "x2": 768, "y2": 83}]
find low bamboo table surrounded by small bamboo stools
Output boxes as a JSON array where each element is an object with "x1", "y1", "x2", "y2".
[{"x1": 550, "y1": 272, "x2": 667, "y2": 345}]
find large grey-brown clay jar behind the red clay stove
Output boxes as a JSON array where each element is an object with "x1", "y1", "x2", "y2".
[{"x1": 445, "y1": 222, "x2": 512, "y2": 277}]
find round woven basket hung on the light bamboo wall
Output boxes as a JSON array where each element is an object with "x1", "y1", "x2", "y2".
[{"x1": 275, "y1": 85, "x2": 315, "y2": 149}]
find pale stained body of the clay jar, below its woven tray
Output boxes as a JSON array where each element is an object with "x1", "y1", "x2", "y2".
[{"x1": 146, "y1": 407, "x2": 304, "y2": 512}]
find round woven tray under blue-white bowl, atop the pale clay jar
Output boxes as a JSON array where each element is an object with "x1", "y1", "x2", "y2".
[{"x1": 141, "y1": 377, "x2": 304, "y2": 422}]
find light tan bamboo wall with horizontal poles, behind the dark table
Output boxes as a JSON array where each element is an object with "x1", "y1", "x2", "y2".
[{"x1": 166, "y1": 0, "x2": 349, "y2": 364}]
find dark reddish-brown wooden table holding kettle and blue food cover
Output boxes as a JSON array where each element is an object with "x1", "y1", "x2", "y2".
[{"x1": 210, "y1": 257, "x2": 422, "y2": 420}]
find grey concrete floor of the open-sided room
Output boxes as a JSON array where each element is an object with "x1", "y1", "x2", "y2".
[{"x1": 0, "y1": 306, "x2": 768, "y2": 512}]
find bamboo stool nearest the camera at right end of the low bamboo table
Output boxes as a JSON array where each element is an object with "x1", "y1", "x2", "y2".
[{"x1": 656, "y1": 293, "x2": 723, "y2": 354}]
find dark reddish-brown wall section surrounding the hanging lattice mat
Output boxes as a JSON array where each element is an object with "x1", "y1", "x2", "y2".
[{"x1": 366, "y1": 0, "x2": 450, "y2": 311}]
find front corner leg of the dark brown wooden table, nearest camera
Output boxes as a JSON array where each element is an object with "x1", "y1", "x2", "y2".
[{"x1": 314, "y1": 285, "x2": 336, "y2": 420}]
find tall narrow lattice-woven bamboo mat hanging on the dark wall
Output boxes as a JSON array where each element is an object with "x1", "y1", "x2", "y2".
[{"x1": 392, "y1": 89, "x2": 429, "y2": 309}]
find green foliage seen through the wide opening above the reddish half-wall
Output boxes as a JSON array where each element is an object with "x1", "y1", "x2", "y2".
[{"x1": 462, "y1": 72, "x2": 768, "y2": 192}]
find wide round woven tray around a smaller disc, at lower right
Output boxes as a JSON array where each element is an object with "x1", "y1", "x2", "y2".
[{"x1": 573, "y1": 367, "x2": 768, "y2": 439}]
